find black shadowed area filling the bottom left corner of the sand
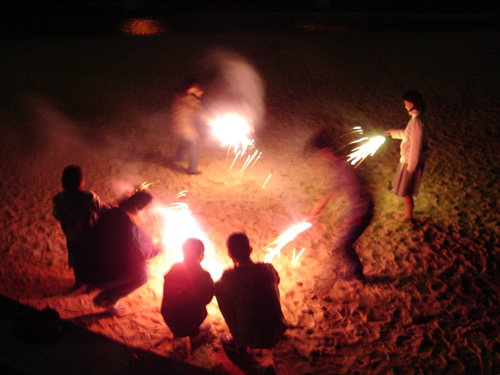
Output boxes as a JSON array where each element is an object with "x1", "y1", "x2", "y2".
[{"x1": 0, "y1": 296, "x2": 217, "y2": 375}]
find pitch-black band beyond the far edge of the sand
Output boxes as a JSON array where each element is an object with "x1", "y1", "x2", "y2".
[{"x1": 0, "y1": 0, "x2": 500, "y2": 38}]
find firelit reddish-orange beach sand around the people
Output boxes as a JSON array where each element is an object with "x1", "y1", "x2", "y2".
[{"x1": 0, "y1": 22, "x2": 500, "y2": 374}]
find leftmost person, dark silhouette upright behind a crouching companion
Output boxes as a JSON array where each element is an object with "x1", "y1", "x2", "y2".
[{"x1": 52, "y1": 165, "x2": 112, "y2": 293}]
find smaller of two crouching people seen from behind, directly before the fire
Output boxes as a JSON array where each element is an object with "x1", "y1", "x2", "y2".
[{"x1": 161, "y1": 238, "x2": 214, "y2": 340}]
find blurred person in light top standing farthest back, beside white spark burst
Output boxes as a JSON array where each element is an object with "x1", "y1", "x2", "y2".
[{"x1": 171, "y1": 79, "x2": 204, "y2": 175}]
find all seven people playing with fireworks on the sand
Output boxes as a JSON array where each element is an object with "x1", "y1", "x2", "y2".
[{"x1": 53, "y1": 88, "x2": 427, "y2": 354}]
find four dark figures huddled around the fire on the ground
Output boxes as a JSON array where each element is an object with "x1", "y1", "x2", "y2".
[{"x1": 53, "y1": 165, "x2": 287, "y2": 355}]
